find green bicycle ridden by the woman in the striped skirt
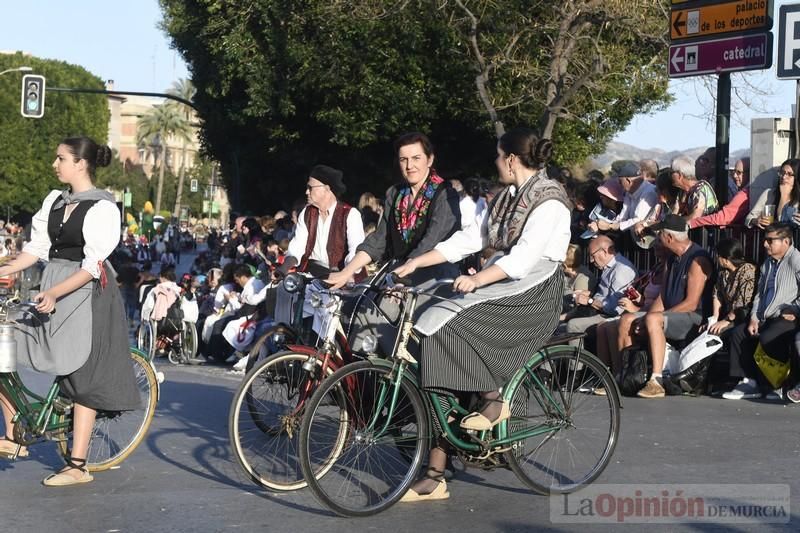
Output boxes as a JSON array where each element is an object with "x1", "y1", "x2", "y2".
[{"x1": 299, "y1": 278, "x2": 620, "y2": 516}]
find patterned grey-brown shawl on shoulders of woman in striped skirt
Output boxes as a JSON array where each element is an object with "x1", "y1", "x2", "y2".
[{"x1": 488, "y1": 170, "x2": 572, "y2": 252}]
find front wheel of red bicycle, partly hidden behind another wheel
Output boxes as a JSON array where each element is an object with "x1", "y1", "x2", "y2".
[{"x1": 228, "y1": 352, "x2": 333, "y2": 491}]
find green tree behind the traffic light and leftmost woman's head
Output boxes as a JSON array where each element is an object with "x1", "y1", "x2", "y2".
[{"x1": 0, "y1": 53, "x2": 109, "y2": 214}]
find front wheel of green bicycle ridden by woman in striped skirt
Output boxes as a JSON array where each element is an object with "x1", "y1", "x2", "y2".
[{"x1": 300, "y1": 361, "x2": 430, "y2": 516}]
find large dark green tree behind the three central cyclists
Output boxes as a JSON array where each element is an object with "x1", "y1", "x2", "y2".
[{"x1": 161, "y1": 0, "x2": 668, "y2": 211}]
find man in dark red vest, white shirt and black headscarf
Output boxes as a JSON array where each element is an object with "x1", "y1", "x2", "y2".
[{"x1": 284, "y1": 165, "x2": 364, "y2": 277}]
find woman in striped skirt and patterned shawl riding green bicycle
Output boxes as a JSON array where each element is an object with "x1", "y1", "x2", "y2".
[{"x1": 396, "y1": 128, "x2": 571, "y2": 502}]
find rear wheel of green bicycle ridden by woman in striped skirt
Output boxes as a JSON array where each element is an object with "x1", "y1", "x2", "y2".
[{"x1": 505, "y1": 347, "x2": 620, "y2": 494}]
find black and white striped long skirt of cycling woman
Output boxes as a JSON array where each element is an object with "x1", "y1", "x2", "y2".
[{"x1": 420, "y1": 268, "x2": 564, "y2": 392}]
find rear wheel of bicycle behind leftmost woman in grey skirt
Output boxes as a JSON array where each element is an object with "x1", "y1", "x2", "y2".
[{"x1": 58, "y1": 352, "x2": 158, "y2": 472}]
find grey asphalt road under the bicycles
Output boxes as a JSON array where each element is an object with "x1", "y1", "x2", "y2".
[{"x1": 0, "y1": 364, "x2": 800, "y2": 533}]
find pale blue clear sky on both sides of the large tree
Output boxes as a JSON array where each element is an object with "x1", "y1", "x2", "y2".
[{"x1": 0, "y1": 0, "x2": 796, "y2": 150}]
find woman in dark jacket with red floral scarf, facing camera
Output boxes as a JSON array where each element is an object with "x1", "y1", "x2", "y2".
[{"x1": 327, "y1": 132, "x2": 461, "y2": 288}]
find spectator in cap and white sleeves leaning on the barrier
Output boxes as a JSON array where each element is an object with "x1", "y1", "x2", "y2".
[{"x1": 589, "y1": 163, "x2": 658, "y2": 239}]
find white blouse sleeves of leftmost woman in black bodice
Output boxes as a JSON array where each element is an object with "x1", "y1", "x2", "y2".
[{"x1": 22, "y1": 190, "x2": 122, "y2": 279}]
